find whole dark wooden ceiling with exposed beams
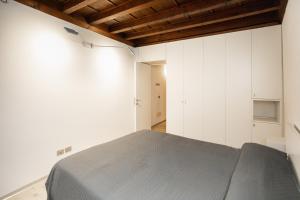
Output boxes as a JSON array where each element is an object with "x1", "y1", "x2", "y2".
[{"x1": 16, "y1": 0, "x2": 288, "y2": 46}]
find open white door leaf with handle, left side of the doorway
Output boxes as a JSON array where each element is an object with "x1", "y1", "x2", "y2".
[{"x1": 135, "y1": 63, "x2": 151, "y2": 131}]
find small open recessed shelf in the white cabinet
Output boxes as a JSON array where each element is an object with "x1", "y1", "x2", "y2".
[{"x1": 253, "y1": 100, "x2": 280, "y2": 123}]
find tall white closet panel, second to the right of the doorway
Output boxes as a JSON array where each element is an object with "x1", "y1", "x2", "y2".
[{"x1": 183, "y1": 38, "x2": 203, "y2": 140}]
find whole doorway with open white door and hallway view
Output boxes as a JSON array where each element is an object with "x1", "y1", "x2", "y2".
[{"x1": 135, "y1": 61, "x2": 166, "y2": 133}]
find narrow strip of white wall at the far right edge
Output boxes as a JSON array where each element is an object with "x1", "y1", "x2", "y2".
[{"x1": 282, "y1": 0, "x2": 300, "y2": 181}]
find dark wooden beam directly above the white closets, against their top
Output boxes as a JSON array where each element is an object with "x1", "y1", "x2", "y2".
[{"x1": 134, "y1": 12, "x2": 280, "y2": 47}]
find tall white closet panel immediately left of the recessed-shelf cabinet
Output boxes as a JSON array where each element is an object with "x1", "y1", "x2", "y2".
[{"x1": 226, "y1": 31, "x2": 252, "y2": 148}]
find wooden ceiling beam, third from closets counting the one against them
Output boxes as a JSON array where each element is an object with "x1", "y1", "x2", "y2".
[{"x1": 110, "y1": 0, "x2": 245, "y2": 33}]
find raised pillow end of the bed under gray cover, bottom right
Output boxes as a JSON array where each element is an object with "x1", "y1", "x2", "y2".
[{"x1": 226, "y1": 144, "x2": 300, "y2": 200}]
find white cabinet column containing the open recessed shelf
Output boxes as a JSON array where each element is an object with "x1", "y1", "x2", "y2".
[{"x1": 252, "y1": 26, "x2": 282, "y2": 145}]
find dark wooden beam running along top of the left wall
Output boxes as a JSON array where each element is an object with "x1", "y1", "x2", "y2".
[{"x1": 16, "y1": 0, "x2": 134, "y2": 46}]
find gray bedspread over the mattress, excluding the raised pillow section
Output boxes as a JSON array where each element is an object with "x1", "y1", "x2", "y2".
[{"x1": 46, "y1": 131, "x2": 239, "y2": 200}]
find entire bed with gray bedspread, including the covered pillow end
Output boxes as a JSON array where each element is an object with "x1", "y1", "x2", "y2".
[{"x1": 46, "y1": 131, "x2": 300, "y2": 200}]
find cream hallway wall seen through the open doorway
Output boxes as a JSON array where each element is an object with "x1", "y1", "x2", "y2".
[{"x1": 151, "y1": 65, "x2": 166, "y2": 126}]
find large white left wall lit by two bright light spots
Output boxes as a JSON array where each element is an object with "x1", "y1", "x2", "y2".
[{"x1": 0, "y1": 1, "x2": 134, "y2": 197}]
